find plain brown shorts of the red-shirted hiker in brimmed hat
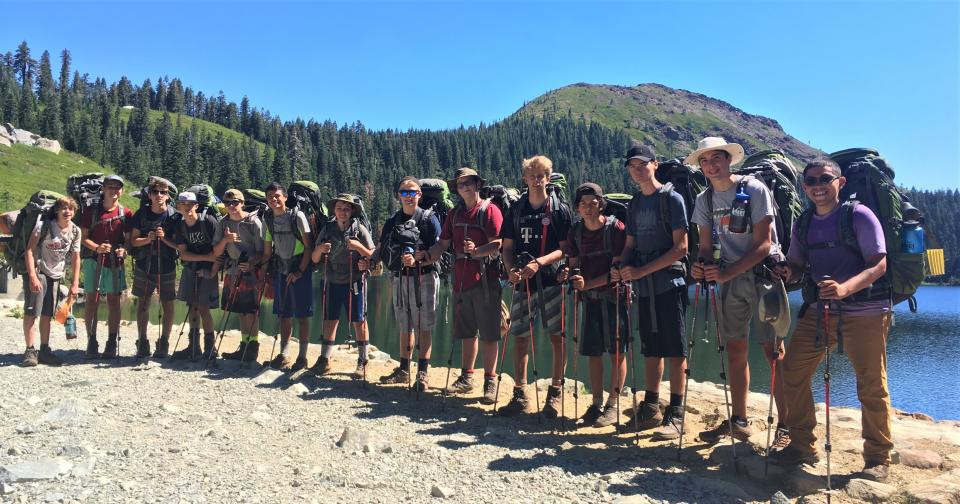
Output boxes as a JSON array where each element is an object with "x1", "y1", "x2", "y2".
[{"x1": 453, "y1": 278, "x2": 502, "y2": 341}]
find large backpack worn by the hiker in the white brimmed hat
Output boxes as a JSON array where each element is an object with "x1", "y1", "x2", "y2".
[{"x1": 732, "y1": 149, "x2": 803, "y2": 254}]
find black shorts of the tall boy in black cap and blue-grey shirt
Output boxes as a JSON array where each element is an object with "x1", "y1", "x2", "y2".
[{"x1": 634, "y1": 285, "x2": 689, "y2": 358}]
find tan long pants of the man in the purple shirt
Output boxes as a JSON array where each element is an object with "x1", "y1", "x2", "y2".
[{"x1": 782, "y1": 305, "x2": 893, "y2": 464}]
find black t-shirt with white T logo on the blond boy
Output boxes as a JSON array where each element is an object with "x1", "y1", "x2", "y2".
[{"x1": 502, "y1": 196, "x2": 573, "y2": 289}]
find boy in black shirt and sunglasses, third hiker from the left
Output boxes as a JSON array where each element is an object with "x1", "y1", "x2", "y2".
[{"x1": 130, "y1": 177, "x2": 177, "y2": 359}]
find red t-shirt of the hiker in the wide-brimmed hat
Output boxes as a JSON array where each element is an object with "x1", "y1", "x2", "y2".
[{"x1": 440, "y1": 200, "x2": 503, "y2": 292}]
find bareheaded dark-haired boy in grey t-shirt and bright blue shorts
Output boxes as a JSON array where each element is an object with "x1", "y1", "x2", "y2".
[{"x1": 263, "y1": 182, "x2": 313, "y2": 372}]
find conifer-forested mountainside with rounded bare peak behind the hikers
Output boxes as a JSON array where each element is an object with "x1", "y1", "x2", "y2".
[{"x1": 0, "y1": 42, "x2": 960, "y2": 276}]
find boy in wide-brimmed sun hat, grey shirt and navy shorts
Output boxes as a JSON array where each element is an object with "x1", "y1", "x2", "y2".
[{"x1": 310, "y1": 193, "x2": 375, "y2": 380}]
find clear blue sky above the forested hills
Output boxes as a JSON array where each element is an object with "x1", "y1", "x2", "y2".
[{"x1": 0, "y1": 1, "x2": 960, "y2": 188}]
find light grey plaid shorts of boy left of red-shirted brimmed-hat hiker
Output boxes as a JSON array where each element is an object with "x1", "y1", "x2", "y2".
[{"x1": 393, "y1": 271, "x2": 440, "y2": 332}]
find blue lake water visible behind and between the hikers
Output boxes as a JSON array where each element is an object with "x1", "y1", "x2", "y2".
[{"x1": 100, "y1": 277, "x2": 960, "y2": 420}]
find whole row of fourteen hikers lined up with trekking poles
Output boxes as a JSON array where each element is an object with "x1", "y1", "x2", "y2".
[{"x1": 3, "y1": 137, "x2": 893, "y2": 480}]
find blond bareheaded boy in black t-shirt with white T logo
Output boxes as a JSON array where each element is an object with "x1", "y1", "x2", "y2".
[{"x1": 500, "y1": 156, "x2": 573, "y2": 418}]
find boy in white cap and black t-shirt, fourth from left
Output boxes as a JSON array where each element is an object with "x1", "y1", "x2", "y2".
[{"x1": 172, "y1": 192, "x2": 220, "y2": 361}]
